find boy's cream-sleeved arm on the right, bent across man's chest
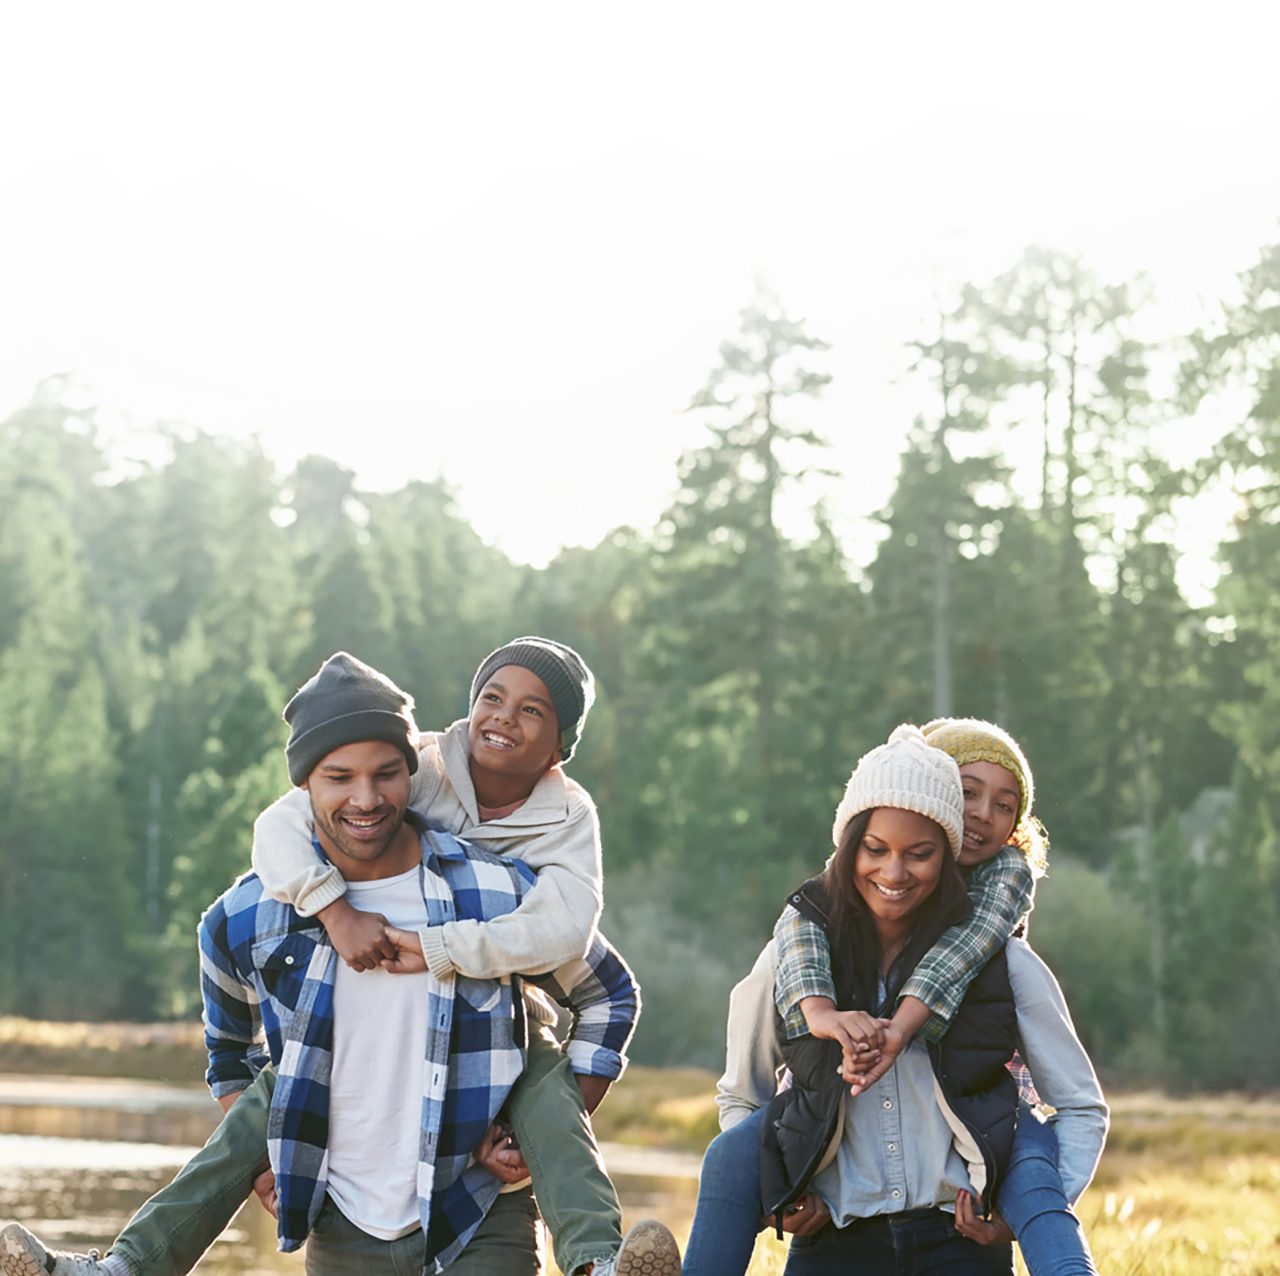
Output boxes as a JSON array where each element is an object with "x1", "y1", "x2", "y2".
[{"x1": 422, "y1": 790, "x2": 603, "y2": 979}]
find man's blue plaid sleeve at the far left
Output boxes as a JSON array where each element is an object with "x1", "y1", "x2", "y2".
[{"x1": 200, "y1": 900, "x2": 268, "y2": 1095}]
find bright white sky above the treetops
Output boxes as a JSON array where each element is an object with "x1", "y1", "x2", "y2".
[{"x1": 0, "y1": 0, "x2": 1280, "y2": 596}]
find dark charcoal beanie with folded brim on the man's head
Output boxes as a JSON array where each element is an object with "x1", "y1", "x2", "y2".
[{"x1": 284, "y1": 651, "x2": 417, "y2": 785}]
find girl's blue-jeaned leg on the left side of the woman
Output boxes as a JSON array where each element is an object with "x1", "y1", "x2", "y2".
[{"x1": 684, "y1": 1108, "x2": 764, "y2": 1276}]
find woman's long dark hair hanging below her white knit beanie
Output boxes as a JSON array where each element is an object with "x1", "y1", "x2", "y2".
[{"x1": 822, "y1": 808, "x2": 970, "y2": 1011}]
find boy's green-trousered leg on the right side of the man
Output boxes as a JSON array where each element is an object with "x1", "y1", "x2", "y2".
[{"x1": 507, "y1": 1029, "x2": 622, "y2": 1276}]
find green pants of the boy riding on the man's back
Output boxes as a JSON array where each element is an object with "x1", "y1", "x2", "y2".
[{"x1": 111, "y1": 1030, "x2": 622, "y2": 1276}]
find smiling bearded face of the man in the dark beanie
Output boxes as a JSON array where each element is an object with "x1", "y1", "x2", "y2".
[{"x1": 302, "y1": 740, "x2": 410, "y2": 881}]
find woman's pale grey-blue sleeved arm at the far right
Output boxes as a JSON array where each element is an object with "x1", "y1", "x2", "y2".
[{"x1": 1007, "y1": 939, "x2": 1110, "y2": 1202}]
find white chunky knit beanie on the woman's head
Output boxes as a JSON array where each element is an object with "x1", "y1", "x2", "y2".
[{"x1": 831, "y1": 722, "x2": 964, "y2": 855}]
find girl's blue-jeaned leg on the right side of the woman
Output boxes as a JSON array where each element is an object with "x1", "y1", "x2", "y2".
[{"x1": 996, "y1": 1107, "x2": 1098, "y2": 1276}]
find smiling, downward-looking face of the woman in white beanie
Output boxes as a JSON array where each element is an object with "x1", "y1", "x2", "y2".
[{"x1": 854, "y1": 806, "x2": 951, "y2": 932}]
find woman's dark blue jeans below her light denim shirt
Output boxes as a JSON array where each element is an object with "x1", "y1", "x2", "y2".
[{"x1": 785, "y1": 1209, "x2": 1014, "y2": 1276}]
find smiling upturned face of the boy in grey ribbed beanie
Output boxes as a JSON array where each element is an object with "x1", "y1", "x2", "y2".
[{"x1": 467, "y1": 664, "x2": 559, "y2": 781}]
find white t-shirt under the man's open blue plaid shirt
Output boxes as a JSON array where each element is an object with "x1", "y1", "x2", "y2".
[{"x1": 328, "y1": 866, "x2": 429, "y2": 1240}]
